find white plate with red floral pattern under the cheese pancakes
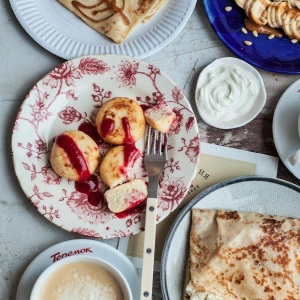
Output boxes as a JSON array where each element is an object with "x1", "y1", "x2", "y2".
[{"x1": 12, "y1": 55, "x2": 200, "y2": 238}]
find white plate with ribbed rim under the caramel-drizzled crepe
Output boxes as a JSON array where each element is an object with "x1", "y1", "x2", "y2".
[{"x1": 10, "y1": 0, "x2": 197, "y2": 59}]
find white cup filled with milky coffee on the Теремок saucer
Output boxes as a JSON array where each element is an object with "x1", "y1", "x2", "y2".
[{"x1": 30, "y1": 255, "x2": 133, "y2": 300}]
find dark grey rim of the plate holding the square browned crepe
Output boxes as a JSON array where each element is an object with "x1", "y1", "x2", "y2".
[{"x1": 160, "y1": 175, "x2": 300, "y2": 300}]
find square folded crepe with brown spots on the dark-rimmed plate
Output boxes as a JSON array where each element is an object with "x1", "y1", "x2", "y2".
[{"x1": 186, "y1": 209, "x2": 300, "y2": 300}]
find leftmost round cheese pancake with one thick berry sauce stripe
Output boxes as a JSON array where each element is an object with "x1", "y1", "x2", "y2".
[{"x1": 50, "y1": 130, "x2": 100, "y2": 181}]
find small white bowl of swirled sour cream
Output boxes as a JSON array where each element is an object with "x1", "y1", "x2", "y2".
[{"x1": 195, "y1": 57, "x2": 267, "y2": 129}]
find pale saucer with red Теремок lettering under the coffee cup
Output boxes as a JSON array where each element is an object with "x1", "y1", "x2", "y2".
[{"x1": 16, "y1": 239, "x2": 141, "y2": 300}]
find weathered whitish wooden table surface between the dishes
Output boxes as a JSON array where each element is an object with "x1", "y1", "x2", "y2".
[{"x1": 0, "y1": 1, "x2": 300, "y2": 300}]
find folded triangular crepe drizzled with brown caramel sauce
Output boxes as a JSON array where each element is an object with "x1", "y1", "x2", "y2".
[{"x1": 59, "y1": 0, "x2": 167, "y2": 43}]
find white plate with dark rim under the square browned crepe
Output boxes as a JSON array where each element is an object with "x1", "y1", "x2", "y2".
[{"x1": 161, "y1": 176, "x2": 300, "y2": 300}]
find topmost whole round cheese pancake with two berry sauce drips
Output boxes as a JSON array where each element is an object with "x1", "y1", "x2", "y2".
[{"x1": 96, "y1": 97, "x2": 145, "y2": 145}]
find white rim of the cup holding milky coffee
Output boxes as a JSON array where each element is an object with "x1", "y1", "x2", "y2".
[{"x1": 30, "y1": 255, "x2": 133, "y2": 300}]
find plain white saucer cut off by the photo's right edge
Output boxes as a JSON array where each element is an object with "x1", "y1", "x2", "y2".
[{"x1": 273, "y1": 80, "x2": 300, "y2": 179}]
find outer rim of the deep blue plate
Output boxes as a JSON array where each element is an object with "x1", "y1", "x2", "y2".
[{"x1": 202, "y1": 0, "x2": 300, "y2": 75}]
